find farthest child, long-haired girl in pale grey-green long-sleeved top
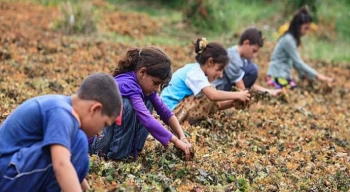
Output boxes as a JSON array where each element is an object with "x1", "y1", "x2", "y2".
[{"x1": 267, "y1": 8, "x2": 333, "y2": 89}]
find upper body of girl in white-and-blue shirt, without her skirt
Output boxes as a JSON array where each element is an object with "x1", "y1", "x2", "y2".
[{"x1": 161, "y1": 38, "x2": 250, "y2": 121}]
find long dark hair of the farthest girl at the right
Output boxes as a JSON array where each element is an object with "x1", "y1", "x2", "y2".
[{"x1": 286, "y1": 8, "x2": 312, "y2": 46}]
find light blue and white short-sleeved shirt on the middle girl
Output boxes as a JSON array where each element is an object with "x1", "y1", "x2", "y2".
[{"x1": 160, "y1": 63, "x2": 211, "y2": 110}]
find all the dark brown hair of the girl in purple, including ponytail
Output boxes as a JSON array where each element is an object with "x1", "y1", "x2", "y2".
[{"x1": 112, "y1": 47, "x2": 172, "y2": 81}]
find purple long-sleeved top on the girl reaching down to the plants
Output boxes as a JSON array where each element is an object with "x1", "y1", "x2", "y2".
[{"x1": 114, "y1": 71, "x2": 174, "y2": 146}]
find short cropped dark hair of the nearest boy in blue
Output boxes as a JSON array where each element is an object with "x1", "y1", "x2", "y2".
[{"x1": 77, "y1": 73, "x2": 122, "y2": 117}]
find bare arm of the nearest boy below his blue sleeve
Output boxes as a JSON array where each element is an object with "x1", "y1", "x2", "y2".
[{"x1": 50, "y1": 145, "x2": 82, "y2": 192}]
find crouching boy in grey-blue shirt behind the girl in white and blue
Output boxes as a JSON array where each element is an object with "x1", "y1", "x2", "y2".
[{"x1": 214, "y1": 28, "x2": 280, "y2": 96}]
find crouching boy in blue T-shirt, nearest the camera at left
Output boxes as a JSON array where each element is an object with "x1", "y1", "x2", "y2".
[{"x1": 0, "y1": 73, "x2": 122, "y2": 192}]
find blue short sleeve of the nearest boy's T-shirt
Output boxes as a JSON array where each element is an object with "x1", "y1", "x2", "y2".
[{"x1": 43, "y1": 108, "x2": 79, "y2": 151}]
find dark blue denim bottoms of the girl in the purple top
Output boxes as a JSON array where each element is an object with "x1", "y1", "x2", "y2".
[{"x1": 89, "y1": 98, "x2": 153, "y2": 160}]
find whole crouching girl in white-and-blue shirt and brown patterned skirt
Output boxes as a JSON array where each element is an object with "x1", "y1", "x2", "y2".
[{"x1": 161, "y1": 38, "x2": 249, "y2": 121}]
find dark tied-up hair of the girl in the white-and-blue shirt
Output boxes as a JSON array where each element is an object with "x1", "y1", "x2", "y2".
[{"x1": 194, "y1": 38, "x2": 229, "y2": 65}]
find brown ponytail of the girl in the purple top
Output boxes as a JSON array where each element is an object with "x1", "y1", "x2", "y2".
[{"x1": 112, "y1": 48, "x2": 141, "y2": 77}]
